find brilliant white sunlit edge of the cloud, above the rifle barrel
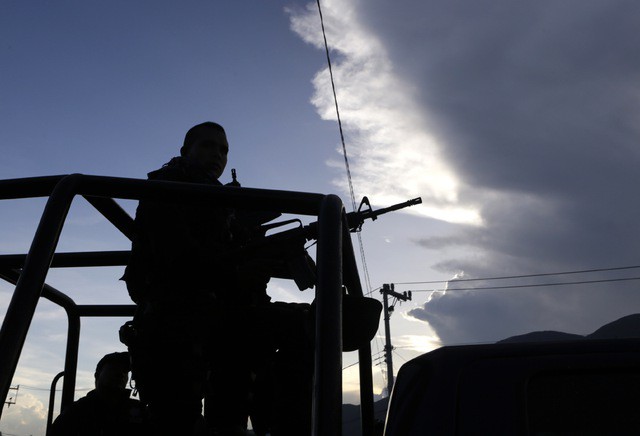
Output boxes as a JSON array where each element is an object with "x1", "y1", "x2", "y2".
[{"x1": 289, "y1": 0, "x2": 482, "y2": 225}]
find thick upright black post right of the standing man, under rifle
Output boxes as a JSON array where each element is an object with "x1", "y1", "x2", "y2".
[{"x1": 312, "y1": 195, "x2": 344, "y2": 436}]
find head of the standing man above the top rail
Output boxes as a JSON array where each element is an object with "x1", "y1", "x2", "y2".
[{"x1": 180, "y1": 121, "x2": 229, "y2": 178}]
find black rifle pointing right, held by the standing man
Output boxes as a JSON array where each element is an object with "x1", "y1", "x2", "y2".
[{"x1": 229, "y1": 197, "x2": 422, "y2": 291}]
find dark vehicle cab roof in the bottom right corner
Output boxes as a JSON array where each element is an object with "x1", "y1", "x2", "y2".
[{"x1": 385, "y1": 338, "x2": 640, "y2": 436}]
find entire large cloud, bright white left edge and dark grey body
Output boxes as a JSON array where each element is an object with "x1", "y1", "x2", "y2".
[{"x1": 292, "y1": 0, "x2": 640, "y2": 343}]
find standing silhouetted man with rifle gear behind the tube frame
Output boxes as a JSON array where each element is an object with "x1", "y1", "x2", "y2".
[{"x1": 123, "y1": 122, "x2": 311, "y2": 435}]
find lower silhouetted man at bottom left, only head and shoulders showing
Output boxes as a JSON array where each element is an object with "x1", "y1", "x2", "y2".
[{"x1": 49, "y1": 352, "x2": 149, "y2": 436}]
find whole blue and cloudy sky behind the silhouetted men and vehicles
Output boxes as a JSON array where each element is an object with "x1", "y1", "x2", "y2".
[{"x1": 0, "y1": 0, "x2": 640, "y2": 435}]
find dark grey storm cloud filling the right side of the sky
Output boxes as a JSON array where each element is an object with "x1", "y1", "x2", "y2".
[{"x1": 361, "y1": 0, "x2": 640, "y2": 343}]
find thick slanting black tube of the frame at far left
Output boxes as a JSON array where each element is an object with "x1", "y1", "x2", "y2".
[{"x1": 0, "y1": 175, "x2": 81, "y2": 417}]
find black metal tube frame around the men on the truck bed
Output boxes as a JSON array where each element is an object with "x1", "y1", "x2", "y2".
[{"x1": 0, "y1": 174, "x2": 373, "y2": 436}]
